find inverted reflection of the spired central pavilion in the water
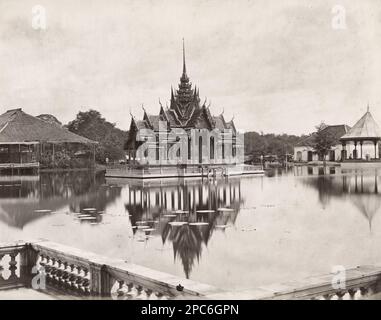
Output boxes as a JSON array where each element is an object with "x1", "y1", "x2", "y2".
[{"x1": 125, "y1": 178, "x2": 243, "y2": 278}]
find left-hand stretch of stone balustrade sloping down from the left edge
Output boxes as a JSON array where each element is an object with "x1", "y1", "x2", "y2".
[{"x1": 0, "y1": 240, "x2": 219, "y2": 299}]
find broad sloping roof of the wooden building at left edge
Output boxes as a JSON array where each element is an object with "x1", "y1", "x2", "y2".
[{"x1": 0, "y1": 109, "x2": 97, "y2": 144}]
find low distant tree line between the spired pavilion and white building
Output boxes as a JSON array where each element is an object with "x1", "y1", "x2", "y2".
[{"x1": 245, "y1": 131, "x2": 305, "y2": 158}]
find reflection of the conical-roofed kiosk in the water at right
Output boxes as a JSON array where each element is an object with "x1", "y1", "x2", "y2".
[{"x1": 303, "y1": 168, "x2": 381, "y2": 229}]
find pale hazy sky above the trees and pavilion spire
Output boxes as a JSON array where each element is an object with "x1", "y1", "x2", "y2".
[{"x1": 0, "y1": 0, "x2": 381, "y2": 135}]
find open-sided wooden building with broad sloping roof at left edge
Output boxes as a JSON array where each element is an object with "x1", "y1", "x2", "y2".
[{"x1": 0, "y1": 109, "x2": 97, "y2": 170}]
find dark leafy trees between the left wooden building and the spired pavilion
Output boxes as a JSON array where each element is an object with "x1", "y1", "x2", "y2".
[{"x1": 67, "y1": 109, "x2": 128, "y2": 163}]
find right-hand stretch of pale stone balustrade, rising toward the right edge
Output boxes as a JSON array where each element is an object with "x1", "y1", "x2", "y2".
[{"x1": 207, "y1": 266, "x2": 381, "y2": 300}]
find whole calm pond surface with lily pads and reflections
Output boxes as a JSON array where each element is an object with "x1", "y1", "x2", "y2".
[{"x1": 0, "y1": 167, "x2": 381, "y2": 290}]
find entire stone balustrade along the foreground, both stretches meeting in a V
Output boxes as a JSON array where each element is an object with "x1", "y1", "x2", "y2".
[{"x1": 0, "y1": 240, "x2": 381, "y2": 300}]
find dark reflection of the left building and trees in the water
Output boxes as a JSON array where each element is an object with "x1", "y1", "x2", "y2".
[{"x1": 0, "y1": 171, "x2": 112, "y2": 229}]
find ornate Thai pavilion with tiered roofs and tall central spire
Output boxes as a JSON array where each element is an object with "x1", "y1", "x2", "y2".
[{"x1": 125, "y1": 43, "x2": 236, "y2": 164}]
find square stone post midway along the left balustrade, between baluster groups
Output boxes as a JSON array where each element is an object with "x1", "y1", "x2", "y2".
[{"x1": 90, "y1": 263, "x2": 113, "y2": 297}]
